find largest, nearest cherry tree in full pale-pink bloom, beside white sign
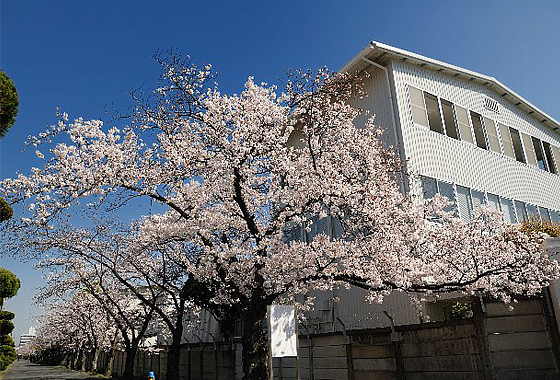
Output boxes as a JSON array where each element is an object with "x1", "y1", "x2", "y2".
[{"x1": 1, "y1": 56, "x2": 559, "y2": 380}]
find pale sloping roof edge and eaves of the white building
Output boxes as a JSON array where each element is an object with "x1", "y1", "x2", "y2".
[{"x1": 340, "y1": 41, "x2": 560, "y2": 132}]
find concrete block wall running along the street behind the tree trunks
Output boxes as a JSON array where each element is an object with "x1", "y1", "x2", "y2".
[{"x1": 69, "y1": 298, "x2": 560, "y2": 380}]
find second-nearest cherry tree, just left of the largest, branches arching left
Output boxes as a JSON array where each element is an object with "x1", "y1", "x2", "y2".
[{"x1": 33, "y1": 222, "x2": 197, "y2": 380}]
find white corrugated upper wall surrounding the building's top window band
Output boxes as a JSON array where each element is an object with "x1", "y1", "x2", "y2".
[{"x1": 391, "y1": 61, "x2": 560, "y2": 210}]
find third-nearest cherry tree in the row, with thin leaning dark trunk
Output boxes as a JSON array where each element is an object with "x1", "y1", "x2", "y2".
[{"x1": 37, "y1": 252, "x2": 158, "y2": 380}]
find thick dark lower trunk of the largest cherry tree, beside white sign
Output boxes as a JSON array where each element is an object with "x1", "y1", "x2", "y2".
[{"x1": 241, "y1": 304, "x2": 269, "y2": 380}]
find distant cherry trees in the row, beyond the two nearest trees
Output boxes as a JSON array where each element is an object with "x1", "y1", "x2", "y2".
[{"x1": 33, "y1": 254, "x2": 161, "y2": 379}]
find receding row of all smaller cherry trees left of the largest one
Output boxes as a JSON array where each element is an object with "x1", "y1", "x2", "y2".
[{"x1": 32, "y1": 224, "x2": 198, "y2": 379}]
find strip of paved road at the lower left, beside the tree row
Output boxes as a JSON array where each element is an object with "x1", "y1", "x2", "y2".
[{"x1": 2, "y1": 360, "x2": 104, "y2": 380}]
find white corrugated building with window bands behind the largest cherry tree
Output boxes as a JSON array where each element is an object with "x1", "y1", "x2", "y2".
[{"x1": 301, "y1": 42, "x2": 560, "y2": 332}]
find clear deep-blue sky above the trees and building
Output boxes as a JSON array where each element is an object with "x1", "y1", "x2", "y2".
[{"x1": 0, "y1": 0, "x2": 560, "y2": 340}]
